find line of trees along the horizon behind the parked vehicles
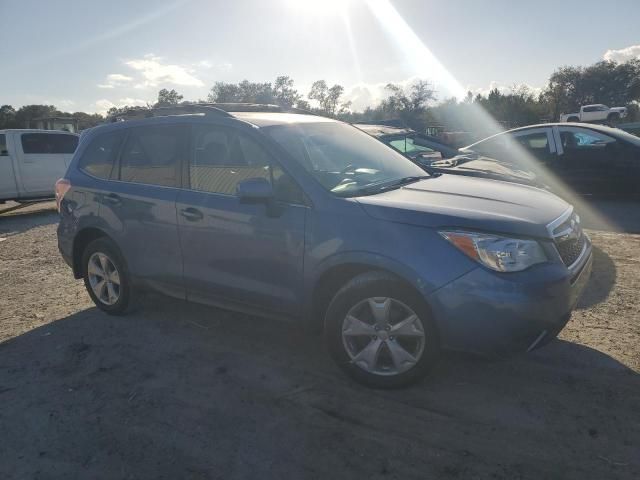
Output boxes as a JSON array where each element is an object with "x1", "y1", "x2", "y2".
[{"x1": 0, "y1": 59, "x2": 640, "y2": 131}]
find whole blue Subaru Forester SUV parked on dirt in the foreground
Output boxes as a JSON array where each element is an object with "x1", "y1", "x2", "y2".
[{"x1": 56, "y1": 104, "x2": 592, "y2": 387}]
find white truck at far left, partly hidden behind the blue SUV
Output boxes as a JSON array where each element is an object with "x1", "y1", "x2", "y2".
[{"x1": 0, "y1": 130, "x2": 79, "y2": 203}]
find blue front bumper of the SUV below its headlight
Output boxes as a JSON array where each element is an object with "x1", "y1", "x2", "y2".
[{"x1": 427, "y1": 245, "x2": 592, "y2": 355}]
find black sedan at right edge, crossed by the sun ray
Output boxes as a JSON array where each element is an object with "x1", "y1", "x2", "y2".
[{"x1": 458, "y1": 123, "x2": 640, "y2": 196}]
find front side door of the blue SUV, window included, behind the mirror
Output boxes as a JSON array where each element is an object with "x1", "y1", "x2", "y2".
[{"x1": 177, "y1": 124, "x2": 308, "y2": 314}]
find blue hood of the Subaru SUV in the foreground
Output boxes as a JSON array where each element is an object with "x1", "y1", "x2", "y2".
[{"x1": 356, "y1": 175, "x2": 570, "y2": 238}]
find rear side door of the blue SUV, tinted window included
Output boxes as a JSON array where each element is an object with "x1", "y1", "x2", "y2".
[{"x1": 98, "y1": 124, "x2": 189, "y2": 297}]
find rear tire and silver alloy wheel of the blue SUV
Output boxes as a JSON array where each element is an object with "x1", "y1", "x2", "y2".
[{"x1": 82, "y1": 238, "x2": 132, "y2": 315}]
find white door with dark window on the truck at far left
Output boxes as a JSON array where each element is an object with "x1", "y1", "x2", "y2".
[{"x1": 15, "y1": 132, "x2": 78, "y2": 197}]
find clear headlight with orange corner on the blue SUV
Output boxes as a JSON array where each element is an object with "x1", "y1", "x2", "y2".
[{"x1": 440, "y1": 231, "x2": 547, "y2": 272}]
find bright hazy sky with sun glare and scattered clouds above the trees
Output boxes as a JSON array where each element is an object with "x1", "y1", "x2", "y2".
[{"x1": 0, "y1": 0, "x2": 640, "y2": 113}]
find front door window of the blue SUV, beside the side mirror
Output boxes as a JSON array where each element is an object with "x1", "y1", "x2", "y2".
[{"x1": 189, "y1": 125, "x2": 304, "y2": 203}]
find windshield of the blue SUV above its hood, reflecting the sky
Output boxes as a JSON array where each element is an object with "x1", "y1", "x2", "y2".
[{"x1": 265, "y1": 122, "x2": 426, "y2": 197}]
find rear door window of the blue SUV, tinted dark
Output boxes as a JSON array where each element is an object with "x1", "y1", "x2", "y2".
[{"x1": 120, "y1": 125, "x2": 188, "y2": 187}]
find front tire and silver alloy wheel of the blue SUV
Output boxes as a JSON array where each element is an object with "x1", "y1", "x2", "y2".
[{"x1": 325, "y1": 271, "x2": 440, "y2": 388}]
